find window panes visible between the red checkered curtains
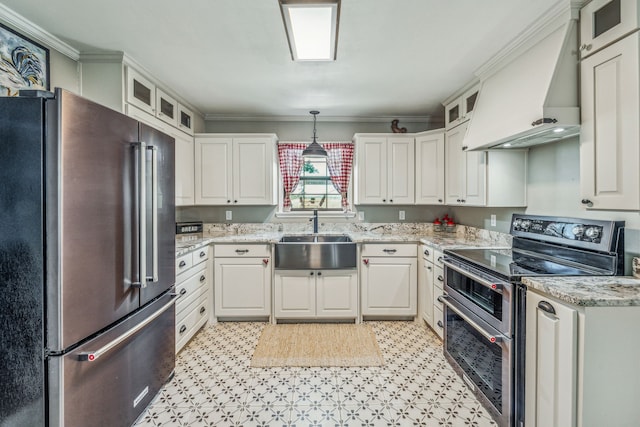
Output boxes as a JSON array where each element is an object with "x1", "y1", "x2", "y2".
[{"x1": 291, "y1": 158, "x2": 342, "y2": 211}]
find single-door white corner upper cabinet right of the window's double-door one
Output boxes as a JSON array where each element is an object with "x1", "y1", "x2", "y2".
[{"x1": 416, "y1": 129, "x2": 445, "y2": 205}]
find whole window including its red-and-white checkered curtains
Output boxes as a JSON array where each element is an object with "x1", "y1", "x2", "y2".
[{"x1": 278, "y1": 142, "x2": 353, "y2": 212}]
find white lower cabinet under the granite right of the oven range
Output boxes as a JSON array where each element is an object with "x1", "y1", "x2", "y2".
[{"x1": 525, "y1": 290, "x2": 640, "y2": 427}]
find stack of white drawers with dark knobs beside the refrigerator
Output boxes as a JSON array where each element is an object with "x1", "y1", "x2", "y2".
[{"x1": 176, "y1": 246, "x2": 211, "y2": 353}]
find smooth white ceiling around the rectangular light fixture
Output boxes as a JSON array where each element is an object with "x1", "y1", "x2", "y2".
[{"x1": 1, "y1": 0, "x2": 558, "y2": 119}]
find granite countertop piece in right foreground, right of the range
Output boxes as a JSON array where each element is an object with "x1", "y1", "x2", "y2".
[{"x1": 522, "y1": 276, "x2": 640, "y2": 307}]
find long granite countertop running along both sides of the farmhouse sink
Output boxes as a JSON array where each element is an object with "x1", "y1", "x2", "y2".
[{"x1": 176, "y1": 231, "x2": 505, "y2": 256}]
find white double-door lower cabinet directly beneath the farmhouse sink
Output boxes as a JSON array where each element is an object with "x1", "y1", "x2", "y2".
[{"x1": 274, "y1": 270, "x2": 358, "y2": 319}]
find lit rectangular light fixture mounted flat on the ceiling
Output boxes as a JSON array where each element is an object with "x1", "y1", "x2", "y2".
[{"x1": 278, "y1": 0, "x2": 340, "y2": 61}]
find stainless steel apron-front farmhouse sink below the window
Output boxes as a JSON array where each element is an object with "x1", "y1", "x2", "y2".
[{"x1": 275, "y1": 234, "x2": 356, "y2": 270}]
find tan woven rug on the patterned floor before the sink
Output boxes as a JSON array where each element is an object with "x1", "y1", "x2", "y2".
[{"x1": 251, "y1": 323, "x2": 384, "y2": 368}]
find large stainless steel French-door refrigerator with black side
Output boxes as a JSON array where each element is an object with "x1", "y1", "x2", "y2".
[{"x1": 0, "y1": 89, "x2": 175, "y2": 427}]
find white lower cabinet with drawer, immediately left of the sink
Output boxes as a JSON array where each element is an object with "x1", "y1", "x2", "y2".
[{"x1": 214, "y1": 244, "x2": 271, "y2": 318}]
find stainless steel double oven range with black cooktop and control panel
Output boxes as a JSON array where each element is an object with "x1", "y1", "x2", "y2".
[{"x1": 439, "y1": 214, "x2": 624, "y2": 427}]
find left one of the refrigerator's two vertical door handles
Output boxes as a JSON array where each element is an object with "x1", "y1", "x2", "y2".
[{"x1": 132, "y1": 141, "x2": 147, "y2": 288}]
